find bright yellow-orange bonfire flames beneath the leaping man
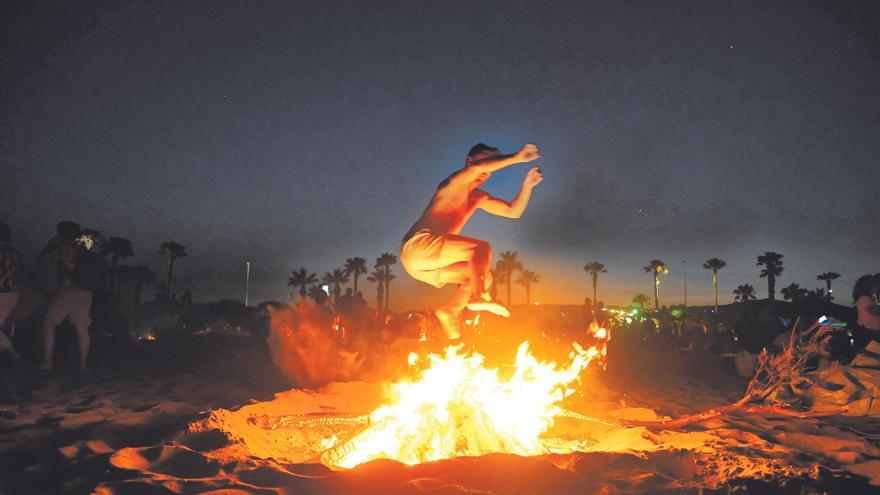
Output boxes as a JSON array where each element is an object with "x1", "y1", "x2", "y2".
[{"x1": 325, "y1": 342, "x2": 600, "y2": 468}]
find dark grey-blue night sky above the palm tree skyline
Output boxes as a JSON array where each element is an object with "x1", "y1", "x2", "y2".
[{"x1": 0, "y1": 0, "x2": 880, "y2": 309}]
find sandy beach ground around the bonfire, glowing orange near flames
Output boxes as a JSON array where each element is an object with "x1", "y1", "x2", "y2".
[{"x1": 0, "y1": 337, "x2": 880, "y2": 494}]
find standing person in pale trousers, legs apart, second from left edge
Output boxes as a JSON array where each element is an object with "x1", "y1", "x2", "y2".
[{"x1": 40, "y1": 239, "x2": 107, "y2": 370}]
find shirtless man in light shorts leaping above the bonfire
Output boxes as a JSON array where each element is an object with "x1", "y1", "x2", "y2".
[{"x1": 400, "y1": 143, "x2": 544, "y2": 340}]
